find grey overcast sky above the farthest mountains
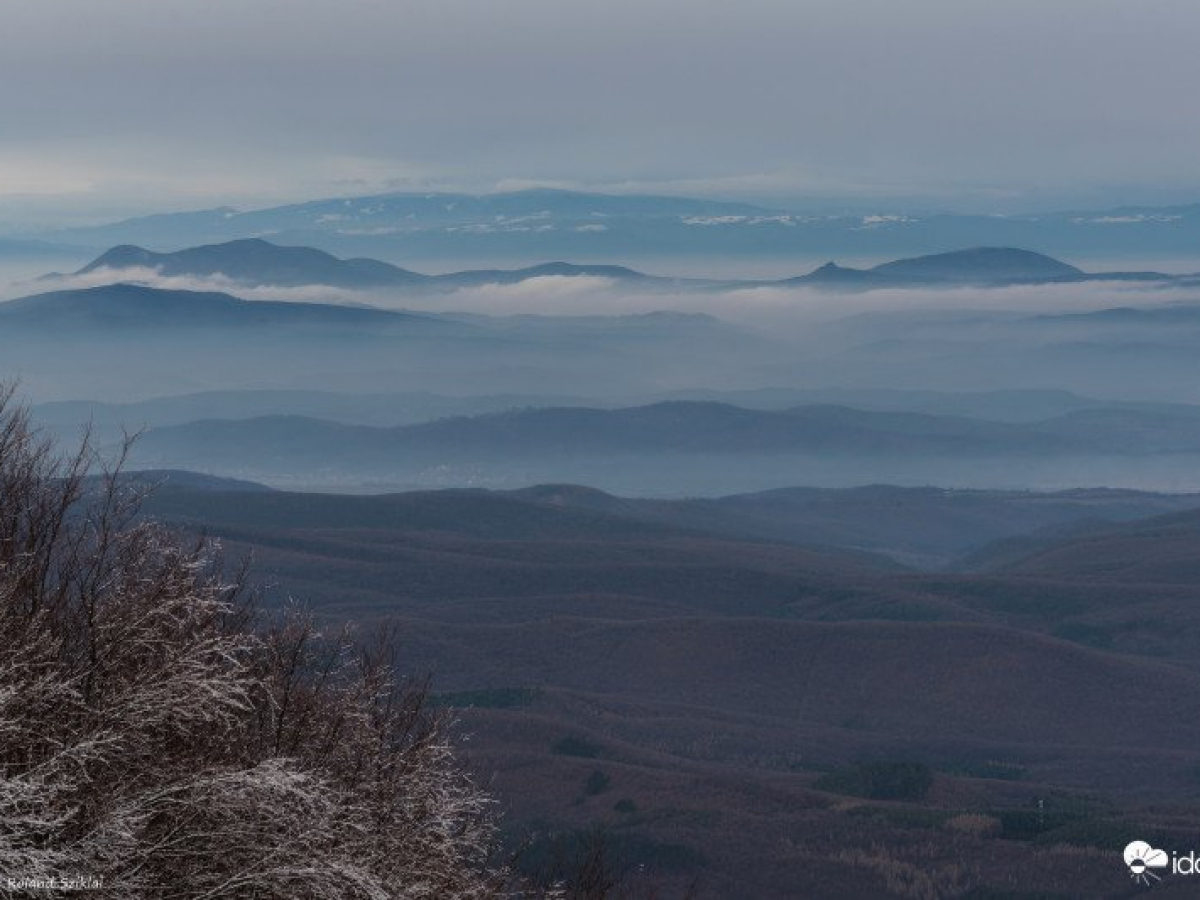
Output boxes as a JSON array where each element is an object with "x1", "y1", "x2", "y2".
[{"x1": 0, "y1": 0, "x2": 1200, "y2": 221}]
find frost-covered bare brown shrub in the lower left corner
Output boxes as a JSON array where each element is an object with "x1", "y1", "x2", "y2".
[{"x1": 0, "y1": 391, "x2": 505, "y2": 900}]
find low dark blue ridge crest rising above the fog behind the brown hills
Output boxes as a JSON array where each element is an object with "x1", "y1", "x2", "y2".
[{"x1": 126, "y1": 402, "x2": 1075, "y2": 470}]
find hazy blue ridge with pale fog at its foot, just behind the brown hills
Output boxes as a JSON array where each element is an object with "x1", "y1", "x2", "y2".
[{"x1": 119, "y1": 402, "x2": 1200, "y2": 496}]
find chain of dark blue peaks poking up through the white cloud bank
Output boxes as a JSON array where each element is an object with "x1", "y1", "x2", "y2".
[{"x1": 58, "y1": 238, "x2": 1171, "y2": 290}]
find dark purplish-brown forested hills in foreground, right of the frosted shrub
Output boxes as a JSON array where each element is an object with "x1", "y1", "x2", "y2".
[{"x1": 140, "y1": 481, "x2": 1200, "y2": 898}]
